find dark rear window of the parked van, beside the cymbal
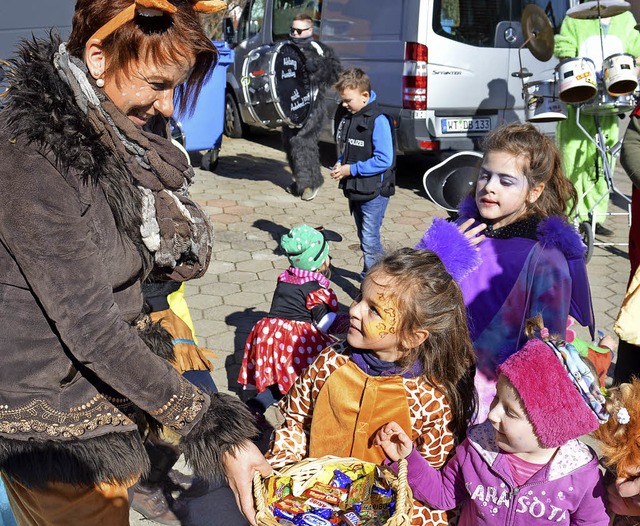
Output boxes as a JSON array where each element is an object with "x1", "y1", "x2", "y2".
[{"x1": 433, "y1": 0, "x2": 569, "y2": 47}]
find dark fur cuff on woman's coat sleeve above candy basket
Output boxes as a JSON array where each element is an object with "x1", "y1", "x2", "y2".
[{"x1": 180, "y1": 393, "x2": 258, "y2": 480}]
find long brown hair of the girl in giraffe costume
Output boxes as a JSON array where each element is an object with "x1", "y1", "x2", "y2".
[{"x1": 365, "y1": 248, "x2": 476, "y2": 443}]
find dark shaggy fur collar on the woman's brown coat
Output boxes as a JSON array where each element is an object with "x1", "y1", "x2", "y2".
[{"x1": 0, "y1": 34, "x2": 151, "y2": 272}]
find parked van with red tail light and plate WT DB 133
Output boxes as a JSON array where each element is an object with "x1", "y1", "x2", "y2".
[{"x1": 225, "y1": 0, "x2": 578, "y2": 157}]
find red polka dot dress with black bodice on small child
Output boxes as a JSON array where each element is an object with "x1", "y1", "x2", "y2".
[{"x1": 238, "y1": 267, "x2": 338, "y2": 394}]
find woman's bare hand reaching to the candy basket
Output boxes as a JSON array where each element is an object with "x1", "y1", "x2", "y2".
[{"x1": 222, "y1": 442, "x2": 273, "y2": 526}]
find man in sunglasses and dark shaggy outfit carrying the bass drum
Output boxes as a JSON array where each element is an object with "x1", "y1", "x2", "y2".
[{"x1": 282, "y1": 13, "x2": 342, "y2": 201}]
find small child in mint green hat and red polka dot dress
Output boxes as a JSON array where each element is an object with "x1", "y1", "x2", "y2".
[{"x1": 238, "y1": 225, "x2": 338, "y2": 417}]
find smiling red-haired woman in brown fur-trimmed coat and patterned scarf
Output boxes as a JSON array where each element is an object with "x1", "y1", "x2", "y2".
[{"x1": 0, "y1": 0, "x2": 270, "y2": 525}]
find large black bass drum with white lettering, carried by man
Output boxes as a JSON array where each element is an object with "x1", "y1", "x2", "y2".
[{"x1": 241, "y1": 41, "x2": 314, "y2": 128}]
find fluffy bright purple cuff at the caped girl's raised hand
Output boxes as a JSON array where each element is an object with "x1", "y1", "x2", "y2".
[{"x1": 416, "y1": 217, "x2": 480, "y2": 284}]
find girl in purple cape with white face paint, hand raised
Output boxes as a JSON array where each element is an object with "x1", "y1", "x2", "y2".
[{"x1": 416, "y1": 124, "x2": 594, "y2": 422}]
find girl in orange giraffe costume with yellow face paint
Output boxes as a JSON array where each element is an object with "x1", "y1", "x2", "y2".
[{"x1": 267, "y1": 248, "x2": 475, "y2": 526}]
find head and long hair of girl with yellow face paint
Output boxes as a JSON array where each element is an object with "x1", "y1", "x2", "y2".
[{"x1": 347, "y1": 249, "x2": 475, "y2": 450}]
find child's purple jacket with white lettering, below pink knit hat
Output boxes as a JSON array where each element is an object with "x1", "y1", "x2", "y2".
[{"x1": 392, "y1": 421, "x2": 609, "y2": 526}]
